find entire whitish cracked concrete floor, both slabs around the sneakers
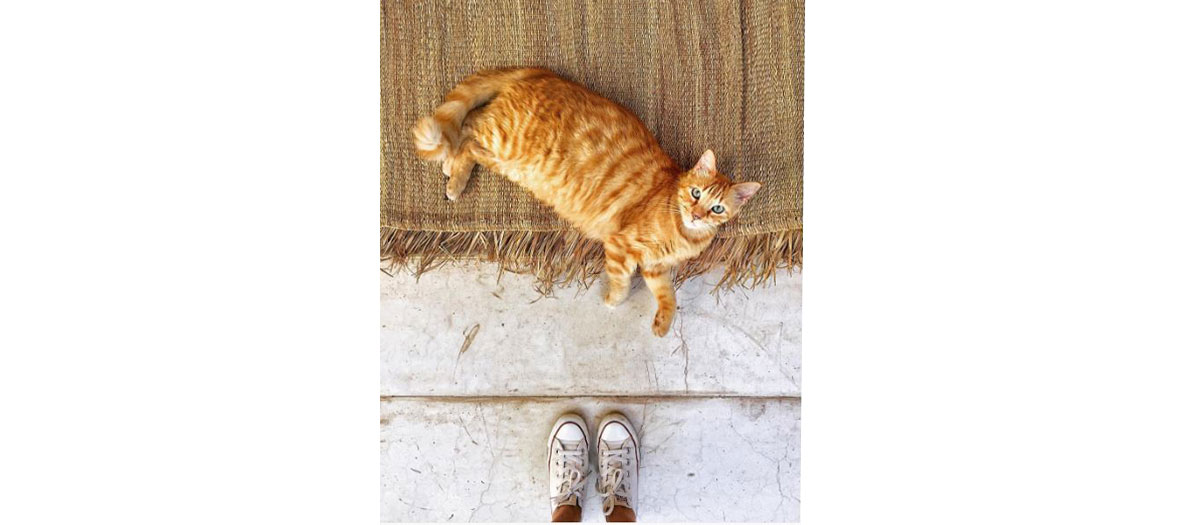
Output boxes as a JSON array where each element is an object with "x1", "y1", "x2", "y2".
[{"x1": 381, "y1": 263, "x2": 801, "y2": 521}]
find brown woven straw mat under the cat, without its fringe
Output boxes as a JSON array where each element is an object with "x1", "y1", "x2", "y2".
[{"x1": 381, "y1": 0, "x2": 804, "y2": 272}]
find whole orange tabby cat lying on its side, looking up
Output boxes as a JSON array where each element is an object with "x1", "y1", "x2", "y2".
[{"x1": 414, "y1": 68, "x2": 761, "y2": 336}]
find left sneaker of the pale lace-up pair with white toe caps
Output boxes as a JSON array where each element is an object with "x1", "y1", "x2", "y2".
[{"x1": 549, "y1": 414, "x2": 590, "y2": 512}]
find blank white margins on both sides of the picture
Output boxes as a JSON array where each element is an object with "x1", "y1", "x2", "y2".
[{"x1": 0, "y1": 1, "x2": 1180, "y2": 524}]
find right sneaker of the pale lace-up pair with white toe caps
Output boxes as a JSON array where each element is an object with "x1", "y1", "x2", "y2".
[{"x1": 597, "y1": 413, "x2": 640, "y2": 514}]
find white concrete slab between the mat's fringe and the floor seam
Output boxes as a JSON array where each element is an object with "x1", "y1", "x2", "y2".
[{"x1": 381, "y1": 263, "x2": 802, "y2": 396}]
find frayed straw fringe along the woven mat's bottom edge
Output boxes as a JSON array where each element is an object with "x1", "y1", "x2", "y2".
[{"x1": 381, "y1": 227, "x2": 802, "y2": 295}]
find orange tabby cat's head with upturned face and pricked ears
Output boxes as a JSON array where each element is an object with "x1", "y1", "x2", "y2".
[{"x1": 676, "y1": 150, "x2": 762, "y2": 231}]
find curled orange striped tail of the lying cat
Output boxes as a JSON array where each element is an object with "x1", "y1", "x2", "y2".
[{"x1": 414, "y1": 67, "x2": 552, "y2": 162}]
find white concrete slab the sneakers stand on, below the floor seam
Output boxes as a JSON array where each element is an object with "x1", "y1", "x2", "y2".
[{"x1": 381, "y1": 398, "x2": 800, "y2": 521}]
